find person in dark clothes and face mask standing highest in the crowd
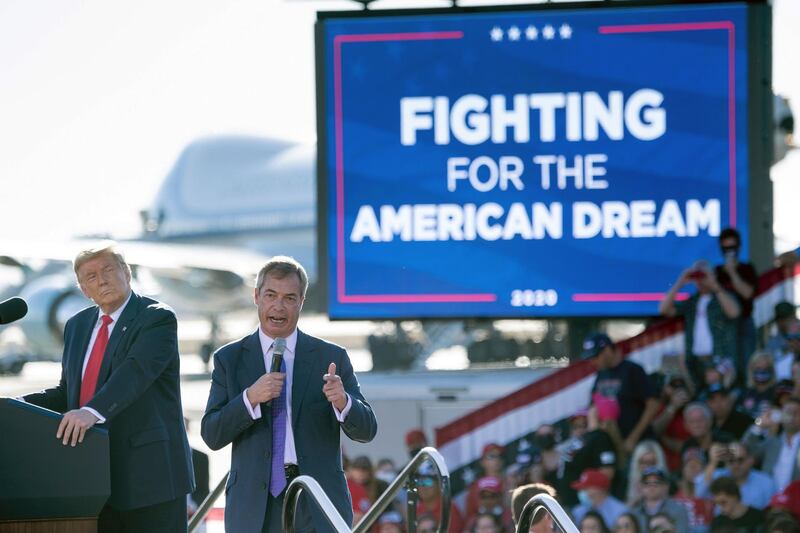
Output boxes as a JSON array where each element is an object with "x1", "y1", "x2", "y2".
[{"x1": 714, "y1": 228, "x2": 758, "y2": 377}]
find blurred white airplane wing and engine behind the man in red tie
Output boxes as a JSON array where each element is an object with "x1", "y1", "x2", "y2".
[{"x1": 0, "y1": 239, "x2": 268, "y2": 368}]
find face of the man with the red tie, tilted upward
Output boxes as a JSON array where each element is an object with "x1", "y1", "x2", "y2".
[{"x1": 78, "y1": 254, "x2": 131, "y2": 314}]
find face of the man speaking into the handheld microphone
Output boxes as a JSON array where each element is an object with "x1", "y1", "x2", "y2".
[{"x1": 253, "y1": 274, "x2": 304, "y2": 339}]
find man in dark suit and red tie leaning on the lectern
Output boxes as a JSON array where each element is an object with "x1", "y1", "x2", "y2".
[{"x1": 24, "y1": 245, "x2": 194, "y2": 533}]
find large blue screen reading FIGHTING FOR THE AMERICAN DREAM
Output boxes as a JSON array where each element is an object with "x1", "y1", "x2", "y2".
[{"x1": 317, "y1": 4, "x2": 764, "y2": 318}]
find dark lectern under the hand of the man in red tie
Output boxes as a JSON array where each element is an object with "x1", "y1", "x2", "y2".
[{"x1": 0, "y1": 398, "x2": 111, "y2": 533}]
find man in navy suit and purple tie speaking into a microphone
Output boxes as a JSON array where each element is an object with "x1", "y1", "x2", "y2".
[{"x1": 201, "y1": 257, "x2": 377, "y2": 533}]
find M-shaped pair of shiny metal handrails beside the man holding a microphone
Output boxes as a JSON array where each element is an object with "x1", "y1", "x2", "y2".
[{"x1": 283, "y1": 446, "x2": 450, "y2": 533}]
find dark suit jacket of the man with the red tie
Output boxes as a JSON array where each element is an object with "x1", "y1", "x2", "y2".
[{"x1": 25, "y1": 293, "x2": 194, "y2": 510}]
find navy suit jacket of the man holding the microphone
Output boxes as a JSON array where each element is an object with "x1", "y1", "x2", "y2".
[{"x1": 201, "y1": 331, "x2": 378, "y2": 533}]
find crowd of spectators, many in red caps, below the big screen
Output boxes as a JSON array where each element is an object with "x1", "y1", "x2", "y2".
[{"x1": 346, "y1": 229, "x2": 800, "y2": 533}]
